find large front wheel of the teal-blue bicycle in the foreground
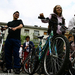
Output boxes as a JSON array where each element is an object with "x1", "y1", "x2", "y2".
[{"x1": 44, "y1": 35, "x2": 70, "y2": 75}]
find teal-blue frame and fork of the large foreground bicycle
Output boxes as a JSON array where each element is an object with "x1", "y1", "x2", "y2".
[{"x1": 37, "y1": 31, "x2": 57, "y2": 61}]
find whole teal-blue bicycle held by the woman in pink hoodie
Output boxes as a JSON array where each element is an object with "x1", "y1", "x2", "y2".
[{"x1": 24, "y1": 18, "x2": 70, "y2": 75}]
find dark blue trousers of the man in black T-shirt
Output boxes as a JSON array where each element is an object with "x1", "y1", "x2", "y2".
[{"x1": 4, "y1": 39, "x2": 21, "y2": 69}]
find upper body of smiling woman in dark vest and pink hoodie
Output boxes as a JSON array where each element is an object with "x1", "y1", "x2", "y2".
[{"x1": 40, "y1": 5, "x2": 65, "y2": 35}]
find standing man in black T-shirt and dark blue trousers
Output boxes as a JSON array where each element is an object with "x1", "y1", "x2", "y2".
[{"x1": 2, "y1": 11, "x2": 24, "y2": 74}]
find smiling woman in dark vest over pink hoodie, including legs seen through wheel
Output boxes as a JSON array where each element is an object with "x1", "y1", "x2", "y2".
[{"x1": 40, "y1": 5, "x2": 65, "y2": 58}]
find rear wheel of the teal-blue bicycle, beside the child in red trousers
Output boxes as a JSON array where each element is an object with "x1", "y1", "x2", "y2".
[{"x1": 24, "y1": 53, "x2": 36, "y2": 74}]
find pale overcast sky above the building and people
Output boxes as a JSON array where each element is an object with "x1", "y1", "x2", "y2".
[{"x1": 0, "y1": 0, "x2": 75, "y2": 27}]
